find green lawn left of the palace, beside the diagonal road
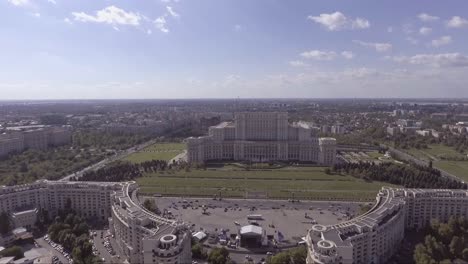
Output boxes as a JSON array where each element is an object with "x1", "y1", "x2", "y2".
[{"x1": 124, "y1": 143, "x2": 185, "y2": 163}]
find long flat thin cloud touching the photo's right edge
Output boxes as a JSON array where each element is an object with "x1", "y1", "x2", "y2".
[{"x1": 392, "y1": 53, "x2": 468, "y2": 67}]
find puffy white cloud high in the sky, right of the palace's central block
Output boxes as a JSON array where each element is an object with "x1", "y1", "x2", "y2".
[{"x1": 307, "y1": 11, "x2": 370, "y2": 31}]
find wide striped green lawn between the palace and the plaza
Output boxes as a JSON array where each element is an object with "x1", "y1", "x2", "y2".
[{"x1": 137, "y1": 167, "x2": 391, "y2": 201}]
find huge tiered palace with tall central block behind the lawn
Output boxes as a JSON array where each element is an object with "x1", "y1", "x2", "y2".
[{"x1": 187, "y1": 112, "x2": 336, "y2": 165}]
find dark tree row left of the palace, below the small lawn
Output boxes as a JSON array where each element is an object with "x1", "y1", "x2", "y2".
[{"x1": 71, "y1": 160, "x2": 171, "y2": 182}]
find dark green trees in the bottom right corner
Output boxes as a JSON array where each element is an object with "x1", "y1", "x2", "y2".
[{"x1": 413, "y1": 217, "x2": 468, "y2": 264}]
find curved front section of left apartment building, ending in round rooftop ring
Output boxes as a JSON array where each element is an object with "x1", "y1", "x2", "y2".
[{"x1": 109, "y1": 183, "x2": 192, "y2": 264}]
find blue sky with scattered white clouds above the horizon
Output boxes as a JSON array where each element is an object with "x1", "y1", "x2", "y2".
[{"x1": 0, "y1": 0, "x2": 468, "y2": 99}]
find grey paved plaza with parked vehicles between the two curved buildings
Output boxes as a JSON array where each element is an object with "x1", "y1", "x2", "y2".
[{"x1": 148, "y1": 197, "x2": 360, "y2": 245}]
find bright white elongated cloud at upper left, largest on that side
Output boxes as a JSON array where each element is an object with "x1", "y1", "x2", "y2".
[{"x1": 72, "y1": 5, "x2": 142, "y2": 26}]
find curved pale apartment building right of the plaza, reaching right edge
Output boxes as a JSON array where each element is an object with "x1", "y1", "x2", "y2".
[{"x1": 306, "y1": 187, "x2": 468, "y2": 264}]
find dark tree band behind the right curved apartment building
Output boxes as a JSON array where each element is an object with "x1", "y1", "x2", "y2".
[{"x1": 331, "y1": 162, "x2": 467, "y2": 189}]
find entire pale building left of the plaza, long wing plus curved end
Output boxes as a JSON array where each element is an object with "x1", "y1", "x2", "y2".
[{"x1": 0, "y1": 180, "x2": 192, "y2": 264}]
